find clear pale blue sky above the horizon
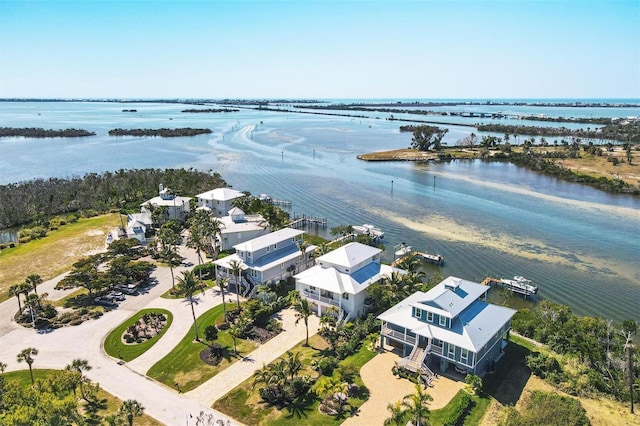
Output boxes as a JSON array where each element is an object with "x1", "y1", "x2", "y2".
[{"x1": 0, "y1": 0, "x2": 640, "y2": 99}]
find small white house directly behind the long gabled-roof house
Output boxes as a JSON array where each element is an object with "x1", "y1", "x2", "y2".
[{"x1": 218, "y1": 207, "x2": 269, "y2": 250}]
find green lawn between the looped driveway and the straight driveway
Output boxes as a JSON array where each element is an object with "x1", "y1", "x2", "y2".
[{"x1": 147, "y1": 304, "x2": 256, "y2": 392}]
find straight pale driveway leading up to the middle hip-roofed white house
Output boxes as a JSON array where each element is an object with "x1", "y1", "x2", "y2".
[{"x1": 185, "y1": 309, "x2": 320, "y2": 407}]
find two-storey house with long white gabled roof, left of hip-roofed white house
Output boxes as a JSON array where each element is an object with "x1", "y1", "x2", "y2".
[{"x1": 213, "y1": 228, "x2": 316, "y2": 294}]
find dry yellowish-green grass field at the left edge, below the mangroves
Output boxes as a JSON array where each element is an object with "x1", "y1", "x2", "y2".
[{"x1": 0, "y1": 213, "x2": 120, "y2": 301}]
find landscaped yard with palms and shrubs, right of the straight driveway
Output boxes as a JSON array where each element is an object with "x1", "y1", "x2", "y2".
[{"x1": 213, "y1": 335, "x2": 376, "y2": 426}]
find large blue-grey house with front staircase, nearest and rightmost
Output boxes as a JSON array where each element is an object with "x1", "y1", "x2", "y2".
[{"x1": 378, "y1": 277, "x2": 516, "y2": 375}]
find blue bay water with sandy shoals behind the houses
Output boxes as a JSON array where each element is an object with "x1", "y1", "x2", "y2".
[{"x1": 0, "y1": 102, "x2": 640, "y2": 320}]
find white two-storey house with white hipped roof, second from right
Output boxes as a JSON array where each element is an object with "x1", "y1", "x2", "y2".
[{"x1": 295, "y1": 242, "x2": 399, "y2": 320}]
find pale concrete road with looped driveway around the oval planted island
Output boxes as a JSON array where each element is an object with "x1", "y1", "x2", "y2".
[{"x1": 0, "y1": 243, "x2": 238, "y2": 425}]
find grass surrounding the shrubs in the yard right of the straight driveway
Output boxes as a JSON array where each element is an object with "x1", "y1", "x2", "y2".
[{"x1": 213, "y1": 335, "x2": 376, "y2": 426}]
